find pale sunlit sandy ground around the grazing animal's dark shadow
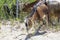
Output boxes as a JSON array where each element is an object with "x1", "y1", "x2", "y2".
[{"x1": 0, "y1": 21, "x2": 60, "y2": 40}]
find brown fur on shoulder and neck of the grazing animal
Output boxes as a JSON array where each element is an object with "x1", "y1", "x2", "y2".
[{"x1": 27, "y1": 4, "x2": 48, "y2": 28}]
